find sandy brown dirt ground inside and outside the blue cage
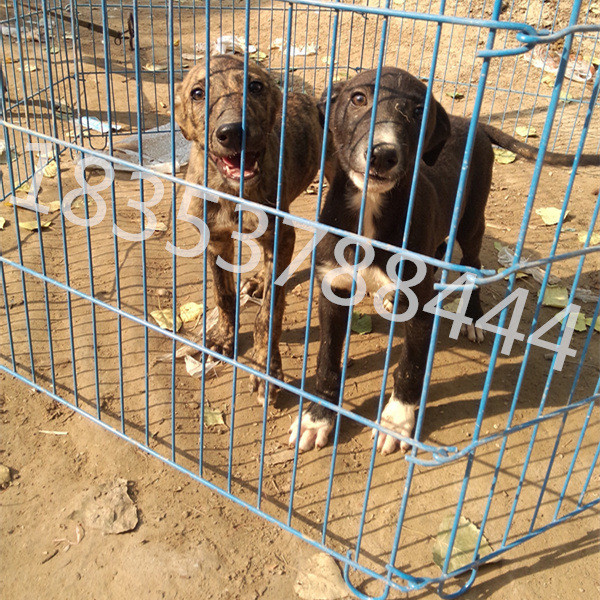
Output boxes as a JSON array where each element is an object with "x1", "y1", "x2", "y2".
[{"x1": 0, "y1": 3, "x2": 600, "y2": 600}]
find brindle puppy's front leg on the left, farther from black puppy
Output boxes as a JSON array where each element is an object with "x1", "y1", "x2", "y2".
[{"x1": 207, "y1": 238, "x2": 236, "y2": 356}]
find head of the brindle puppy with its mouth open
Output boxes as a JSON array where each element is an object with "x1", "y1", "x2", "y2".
[{"x1": 175, "y1": 55, "x2": 281, "y2": 187}]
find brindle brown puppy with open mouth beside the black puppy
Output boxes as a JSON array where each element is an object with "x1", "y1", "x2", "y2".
[{"x1": 175, "y1": 55, "x2": 323, "y2": 403}]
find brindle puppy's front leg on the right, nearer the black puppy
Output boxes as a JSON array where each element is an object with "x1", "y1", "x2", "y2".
[{"x1": 250, "y1": 224, "x2": 296, "y2": 404}]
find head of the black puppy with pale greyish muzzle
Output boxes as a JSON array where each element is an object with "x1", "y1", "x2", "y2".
[{"x1": 320, "y1": 67, "x2": 450, "y2": 193}]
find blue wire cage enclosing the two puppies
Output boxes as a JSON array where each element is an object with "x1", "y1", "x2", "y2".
[{"x1": 0, "y1": 0, "x2": 600, "y2": 598}]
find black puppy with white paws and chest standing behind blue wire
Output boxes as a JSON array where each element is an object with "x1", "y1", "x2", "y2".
[{"x1": 290, "y1": 67, "x2": 600, "y2": 454}]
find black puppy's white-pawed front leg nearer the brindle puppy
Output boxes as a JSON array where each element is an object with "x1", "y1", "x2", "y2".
[{"x1": 289, "y1": 289, "x2": 350, "y2": 451}]
